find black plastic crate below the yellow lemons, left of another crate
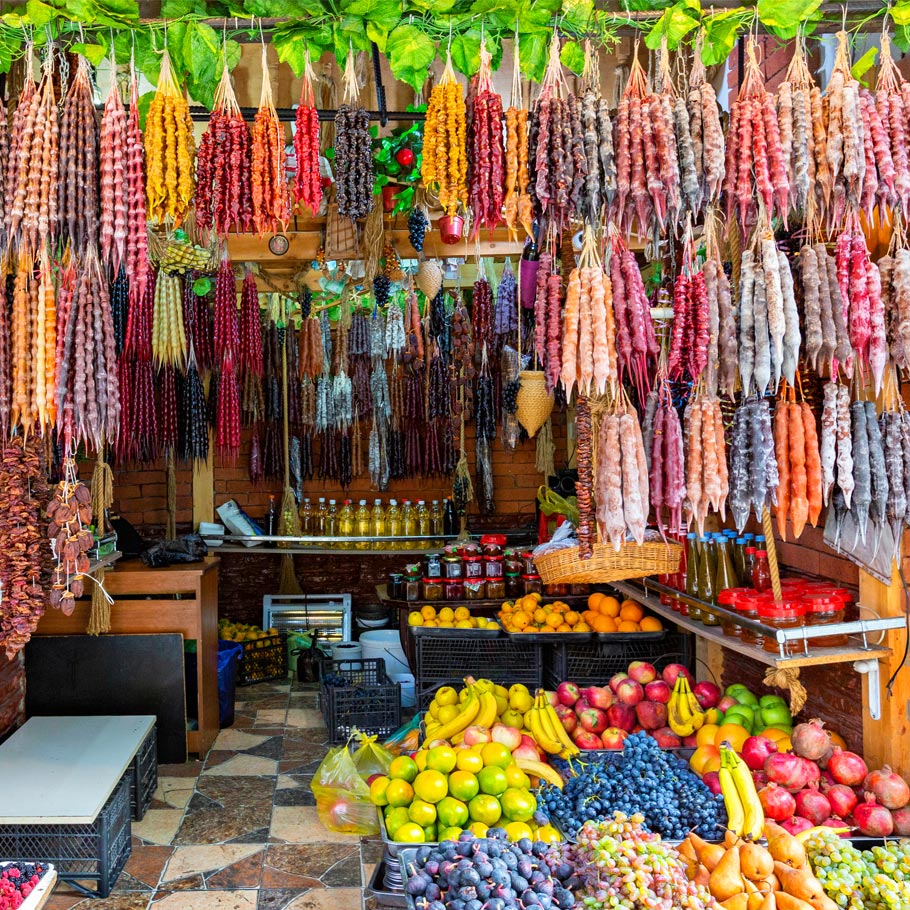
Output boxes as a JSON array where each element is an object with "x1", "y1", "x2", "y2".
[{"x1": 415, "y1": 635, "x2": 546, "y2": 709}]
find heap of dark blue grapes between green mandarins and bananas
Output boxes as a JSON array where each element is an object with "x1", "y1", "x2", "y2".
[{"x1": 539, "y1": 732, "x2": 725, "y2": 840}]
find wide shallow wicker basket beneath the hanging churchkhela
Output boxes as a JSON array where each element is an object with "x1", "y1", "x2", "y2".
[{"x1": 534, "y1": 540, "x2": 682, "y2": 585}]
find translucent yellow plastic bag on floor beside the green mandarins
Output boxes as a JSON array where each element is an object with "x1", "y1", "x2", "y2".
[{"x1": 310, "y1": 740, "x2": 379, "y2": 836}]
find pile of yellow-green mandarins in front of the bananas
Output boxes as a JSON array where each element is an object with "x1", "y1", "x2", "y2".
[{"x1": 370, "y1": 742, "x2": 558, "y2": 844}]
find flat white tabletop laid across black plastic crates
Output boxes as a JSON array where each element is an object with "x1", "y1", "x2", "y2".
[{"x1": 0, "y1": 714, "x2": 155, "y2": 832}]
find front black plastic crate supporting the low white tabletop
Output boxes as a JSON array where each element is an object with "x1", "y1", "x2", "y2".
[{"x1": 0, "y1": 771, "x2": 132, "y2": 897}]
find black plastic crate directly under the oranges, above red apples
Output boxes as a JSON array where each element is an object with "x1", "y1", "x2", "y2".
[{"x1": 543, "y1": 632, "x2": 692, "y2": 689}]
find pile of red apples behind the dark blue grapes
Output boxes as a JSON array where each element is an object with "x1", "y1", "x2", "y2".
[{"x1": 555, "y1": 660, "x2": 707, "y2": 751}]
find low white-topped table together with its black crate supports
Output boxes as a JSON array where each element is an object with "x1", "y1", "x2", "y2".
[{"x1": 0, "y1": 715, "x2": 157, "y2": 897}]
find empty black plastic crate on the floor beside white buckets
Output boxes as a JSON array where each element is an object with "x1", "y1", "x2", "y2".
[{"x1": 319, "y1": 658, "x2": 401, "y2": 743}]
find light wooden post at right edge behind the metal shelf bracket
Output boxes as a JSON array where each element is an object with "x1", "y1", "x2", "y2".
[{"x1": 859, "y1": 566, "x2": 910, "y2": 775}]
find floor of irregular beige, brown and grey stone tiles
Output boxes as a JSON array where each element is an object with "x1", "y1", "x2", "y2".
[{"x1": 47, "y1": 683, "x2": 381, "y2": 910}]
